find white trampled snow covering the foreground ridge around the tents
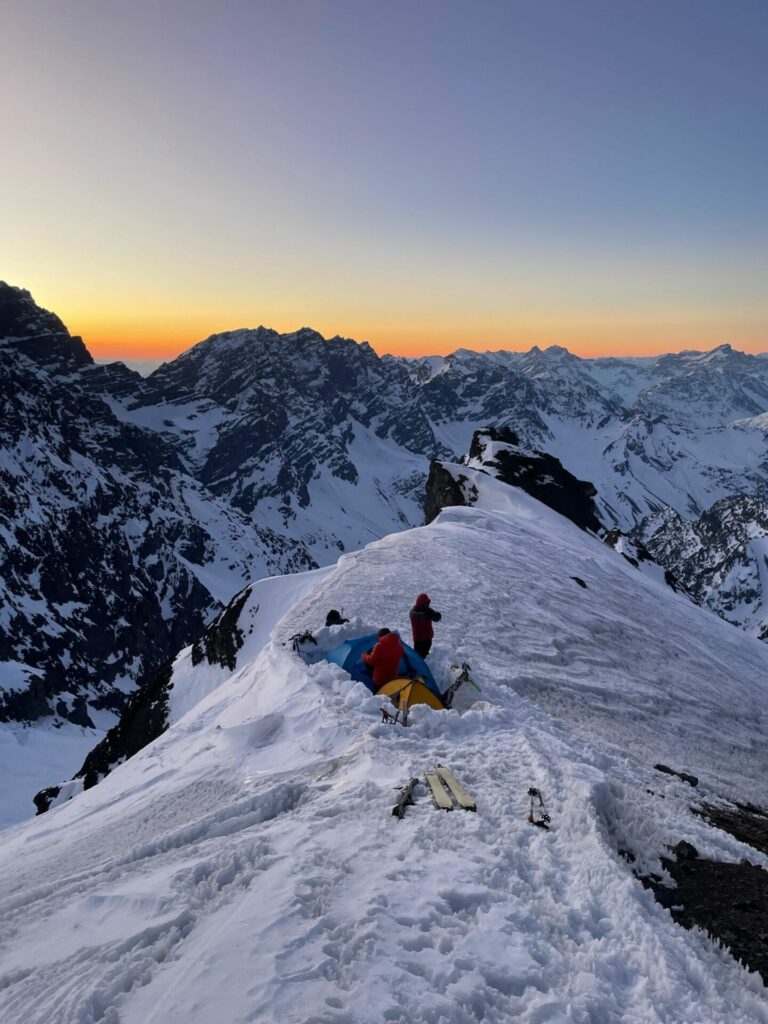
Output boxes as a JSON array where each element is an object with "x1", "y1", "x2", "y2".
[{"x1": 0, "y1": 481, "x2": 768, "y2": 1024}]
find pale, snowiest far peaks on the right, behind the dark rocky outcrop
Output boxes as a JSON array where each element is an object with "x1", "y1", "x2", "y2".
[{"x1": 411, "y1": 345, "x2": 768, "y2": 530}]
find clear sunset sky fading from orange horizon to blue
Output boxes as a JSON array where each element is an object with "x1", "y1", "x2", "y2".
[{"x1": 0, "y1": 0, "x2": 768, "y2": 358}]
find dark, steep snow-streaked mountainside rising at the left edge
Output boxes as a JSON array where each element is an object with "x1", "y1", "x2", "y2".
[{"x1": 0, "y1": 286, "x2": 314, "y2": 798}]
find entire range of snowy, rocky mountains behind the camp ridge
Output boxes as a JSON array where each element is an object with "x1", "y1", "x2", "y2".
[{"x1": 0, "y1": 285, "x2": 768, "y2": 737}]
